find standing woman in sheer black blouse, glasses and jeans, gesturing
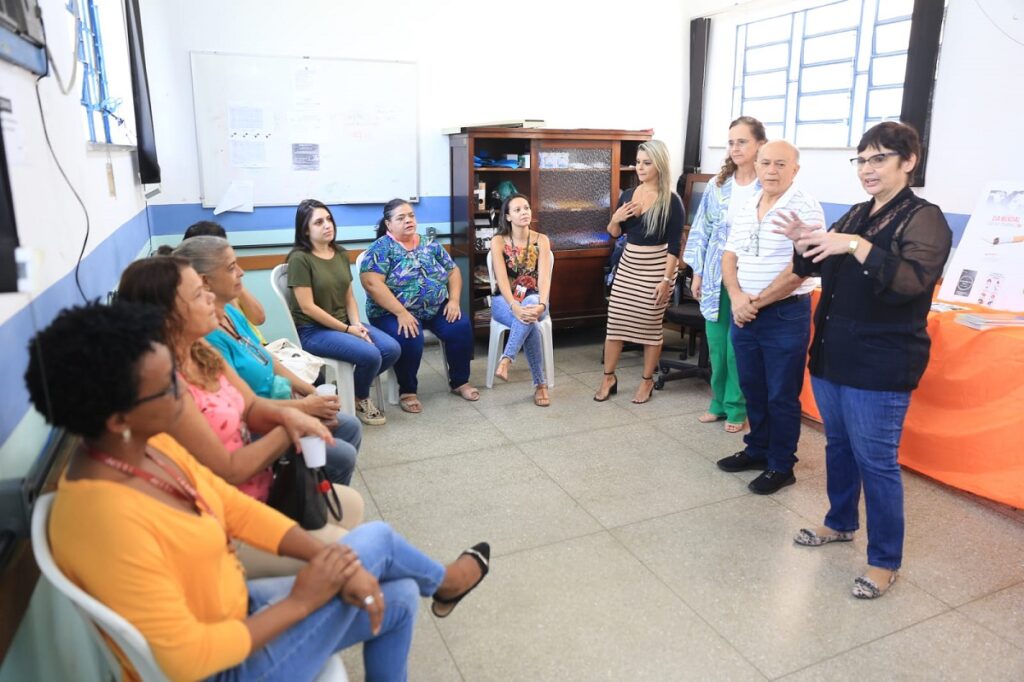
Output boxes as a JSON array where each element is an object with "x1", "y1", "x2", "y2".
[{"x1": 776, "y1": 121, "x2": 952, "y2": 599}]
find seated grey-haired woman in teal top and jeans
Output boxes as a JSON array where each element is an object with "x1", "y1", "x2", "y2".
[{"x1": 174, "y1": 237, "x2": 362, "y2": 485}]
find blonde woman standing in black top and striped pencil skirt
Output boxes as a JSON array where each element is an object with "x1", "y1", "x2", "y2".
[{"x1": 594, "y1": 139, "x2": 685, "y2": 404}]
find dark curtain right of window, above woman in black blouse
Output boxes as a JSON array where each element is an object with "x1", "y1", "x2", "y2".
[{"x1": 900, "y1": 0, "x2": 945, "y2": 187}]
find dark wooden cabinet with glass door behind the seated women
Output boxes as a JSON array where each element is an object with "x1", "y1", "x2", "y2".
[{"x1": 451, "y1": 128, "x2": 651, "y2": 331}]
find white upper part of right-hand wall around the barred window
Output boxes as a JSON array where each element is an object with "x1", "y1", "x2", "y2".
[{"x1": 688, "y1": 0, "x2": 1024, "y2": 214}]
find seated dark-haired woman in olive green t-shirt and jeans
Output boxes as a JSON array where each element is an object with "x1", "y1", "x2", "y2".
[{"x1": 288, "y1": 199, "x2": 401, "y2": 425}]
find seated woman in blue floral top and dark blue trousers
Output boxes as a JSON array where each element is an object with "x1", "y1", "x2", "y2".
[{"x1": 359, "y1": 199, "x2": 480, "y2": 413}]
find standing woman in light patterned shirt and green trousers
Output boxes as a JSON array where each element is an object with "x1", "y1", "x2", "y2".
[{"x1": 683, "y1": 116, "x2": 767, "y2": 433}]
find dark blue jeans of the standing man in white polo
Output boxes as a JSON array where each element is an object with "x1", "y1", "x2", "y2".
[{"x1": 722, "y1": 296, "x2": 811, "y2": 472}]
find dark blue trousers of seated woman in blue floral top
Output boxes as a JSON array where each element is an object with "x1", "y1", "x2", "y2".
[{"x1": 371, "y1": 301, "x2": 473, "y2": 395}]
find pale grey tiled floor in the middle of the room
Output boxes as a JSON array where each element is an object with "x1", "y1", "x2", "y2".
[{"x1": 345, "y1": 333, "x2": 1024, "y2": 681}]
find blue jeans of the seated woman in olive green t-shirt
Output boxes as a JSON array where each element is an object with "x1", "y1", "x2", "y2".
[{"x1": 297, "y1": 325, "x2": 401, "y2": 400}]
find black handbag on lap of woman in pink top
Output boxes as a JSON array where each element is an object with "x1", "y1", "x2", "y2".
[{"x1": 266, "y1": 450, "x2": 342, "y2": 530}]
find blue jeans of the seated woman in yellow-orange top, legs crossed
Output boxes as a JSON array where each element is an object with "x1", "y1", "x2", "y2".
[{"x1": 208, "y1": 521, "x2": 444, "y2": 682}]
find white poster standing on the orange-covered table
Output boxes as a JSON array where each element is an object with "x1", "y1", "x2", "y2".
[{"x1": 939, "y1": 181, "x2": 1024, "y2": 311}]
